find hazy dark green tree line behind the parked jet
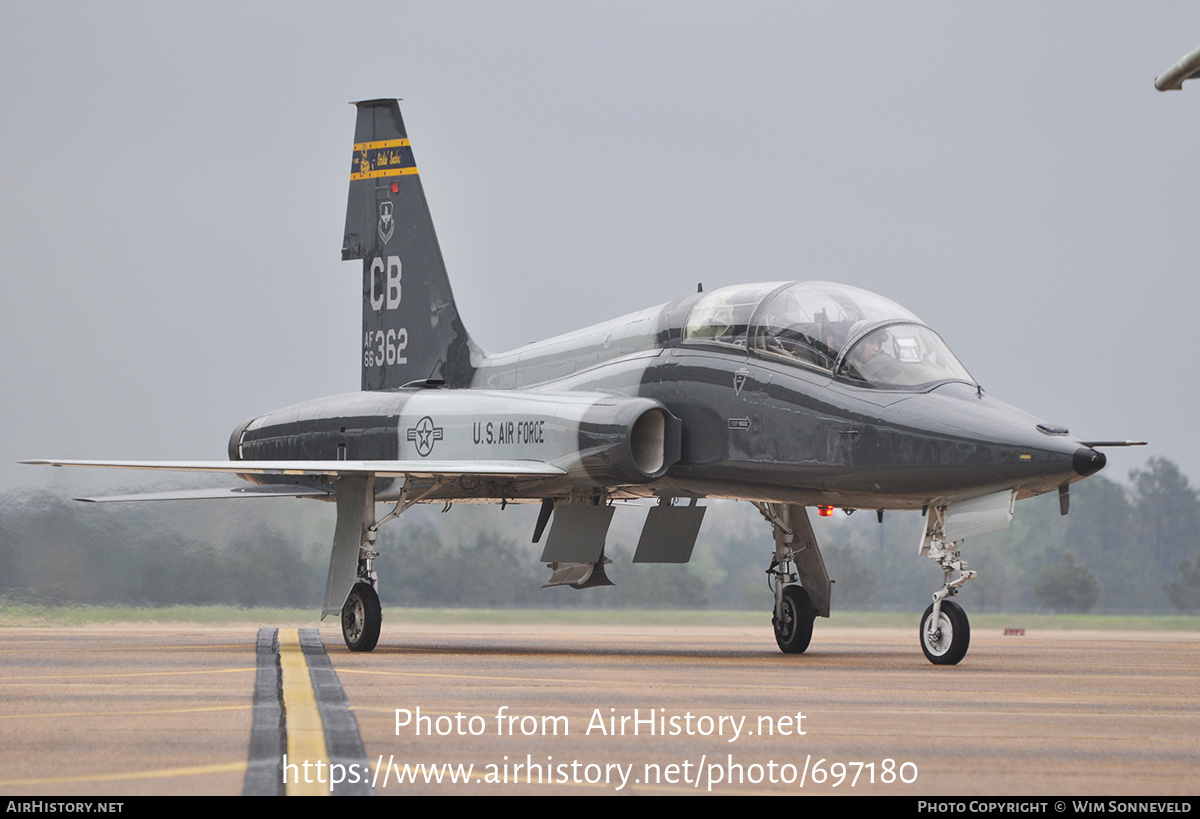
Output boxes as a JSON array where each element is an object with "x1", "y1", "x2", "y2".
[{"x1": 0, "y1": 459, "x2": 1200, "y2": 612}]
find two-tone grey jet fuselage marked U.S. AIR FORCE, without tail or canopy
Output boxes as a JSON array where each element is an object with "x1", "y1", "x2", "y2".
[{"x1": 230, "y1": 283, "x2": 1103, "y2": 509}]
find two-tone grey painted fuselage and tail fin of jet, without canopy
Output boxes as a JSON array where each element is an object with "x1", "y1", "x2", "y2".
[{"x1": 230, "y1": 100, "x2": 1104, "y2": 509}]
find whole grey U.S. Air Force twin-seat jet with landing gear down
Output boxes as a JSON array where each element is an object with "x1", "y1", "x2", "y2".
[{"x1": 28, "y1": 100, "x2": 1133, "y2": 664}]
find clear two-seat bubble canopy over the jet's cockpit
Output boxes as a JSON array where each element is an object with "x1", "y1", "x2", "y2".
[{"x1": 684, "y1": 281, "x2": 976, "y2": 388}]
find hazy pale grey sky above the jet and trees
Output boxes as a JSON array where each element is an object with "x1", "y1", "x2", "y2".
[{"x1": 0, "y1": 0, "x2": 1200, "y2": 488}]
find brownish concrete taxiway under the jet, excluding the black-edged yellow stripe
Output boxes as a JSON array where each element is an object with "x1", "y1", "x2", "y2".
[{"x1": 0, "y1": 612, "x2": 1200, "y2": 796}]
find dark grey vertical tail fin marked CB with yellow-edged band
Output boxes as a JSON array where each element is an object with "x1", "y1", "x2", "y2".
[{"x1": 342, "y1": 100, "x2": 473, "y2": 390}]
